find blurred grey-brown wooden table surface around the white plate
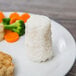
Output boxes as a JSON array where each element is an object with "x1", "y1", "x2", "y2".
[{"x1": 0, "y1": 0, "x2": 76, "y2": 76}]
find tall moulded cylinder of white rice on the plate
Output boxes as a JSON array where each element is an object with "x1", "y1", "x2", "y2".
[{"x1": 25, "y1": 15, "x2": 53, "y2": 62}]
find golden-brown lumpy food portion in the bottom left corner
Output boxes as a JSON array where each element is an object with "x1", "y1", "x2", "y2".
[{"x1": 0, "y1": 52, "x2": 14, "y2": 76}]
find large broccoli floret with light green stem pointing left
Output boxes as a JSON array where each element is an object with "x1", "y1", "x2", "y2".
[{"x1": 4, "y1": 20, "x2": 25, "y2": 36}]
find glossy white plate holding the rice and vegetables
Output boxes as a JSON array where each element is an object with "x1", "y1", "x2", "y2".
[{"x1": 0, "y1": 12, "x2": 76, "y2": 76}]
